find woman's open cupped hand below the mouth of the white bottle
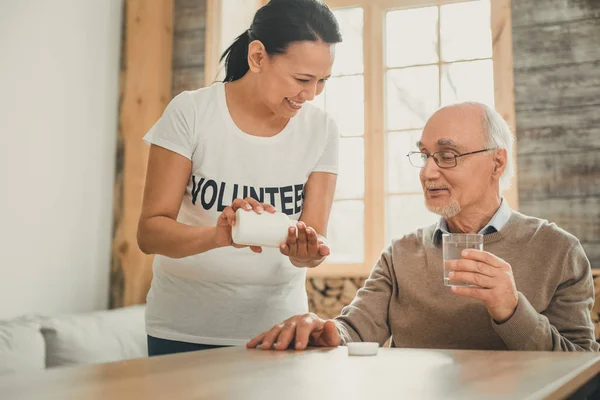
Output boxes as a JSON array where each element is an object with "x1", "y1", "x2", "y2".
[{"x1": 279, "y1": 221, "x2": 331, "y2": 268}]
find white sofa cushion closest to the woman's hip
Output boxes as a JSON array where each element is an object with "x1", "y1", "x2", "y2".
[{"x1": 42, "y1": 306, "x2": 148, "y2": 367}]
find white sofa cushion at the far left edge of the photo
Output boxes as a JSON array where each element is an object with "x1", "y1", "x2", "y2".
[{"x1": 0, "y1": 317, "x2": 46, "y2": 375}]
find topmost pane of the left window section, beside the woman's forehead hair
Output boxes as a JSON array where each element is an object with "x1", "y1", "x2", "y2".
[{"x1": 332, "y1": 8, "x2": 364, "y2": 75}]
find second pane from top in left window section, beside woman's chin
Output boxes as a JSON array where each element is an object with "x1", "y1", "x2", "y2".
[{"x1": 325, "y1": 75, "x2": 365, "y2": 136}]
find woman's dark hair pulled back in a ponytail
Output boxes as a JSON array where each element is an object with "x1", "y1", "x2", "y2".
[{"x1": 220, "y1": 0, "x2": 342, "y2": 82}]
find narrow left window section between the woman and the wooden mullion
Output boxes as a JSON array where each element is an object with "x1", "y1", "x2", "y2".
[{"x1": 314, "y1": 7, "x2": 365, "y2": 265}]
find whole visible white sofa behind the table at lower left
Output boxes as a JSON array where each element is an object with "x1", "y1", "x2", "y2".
[{"x1": 0, "y1": 305, "x2": 148, "y2": 376}]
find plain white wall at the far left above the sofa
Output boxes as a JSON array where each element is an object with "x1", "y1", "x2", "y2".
[{"x1": 0, "y1": 0, "x2": 122, "y2": 319}]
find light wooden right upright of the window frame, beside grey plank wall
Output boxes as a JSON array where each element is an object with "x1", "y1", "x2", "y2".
[{"x1": 490, "y1": 0, "x2": 519, "y2": 210}]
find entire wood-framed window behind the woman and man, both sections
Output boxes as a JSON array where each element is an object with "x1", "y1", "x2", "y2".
[{"x1": 310, "y1": 0, "x2": 516, "y2": 276}]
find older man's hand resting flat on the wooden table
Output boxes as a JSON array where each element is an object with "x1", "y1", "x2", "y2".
[{"x1": 246, "y1": 313, "x2": 341, "y2": 350}]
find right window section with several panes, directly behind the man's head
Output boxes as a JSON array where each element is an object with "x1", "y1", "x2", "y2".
[{"x1": 384, "y1": 0, "x2": 494, "y2": 243}]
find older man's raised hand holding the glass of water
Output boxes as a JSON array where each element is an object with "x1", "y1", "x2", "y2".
[{"x1": 446, "y1": 249, "x2": 519, "y2": 324}]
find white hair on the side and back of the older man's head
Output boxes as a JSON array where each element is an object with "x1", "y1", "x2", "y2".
[{"x1": 463, "y1": 101, "x2": 515, "y2": 193}]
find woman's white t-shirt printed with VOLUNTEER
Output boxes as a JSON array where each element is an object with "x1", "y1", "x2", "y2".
[{"x1": 144, "y1": 84, "x2": 339, "y2": 345}]
